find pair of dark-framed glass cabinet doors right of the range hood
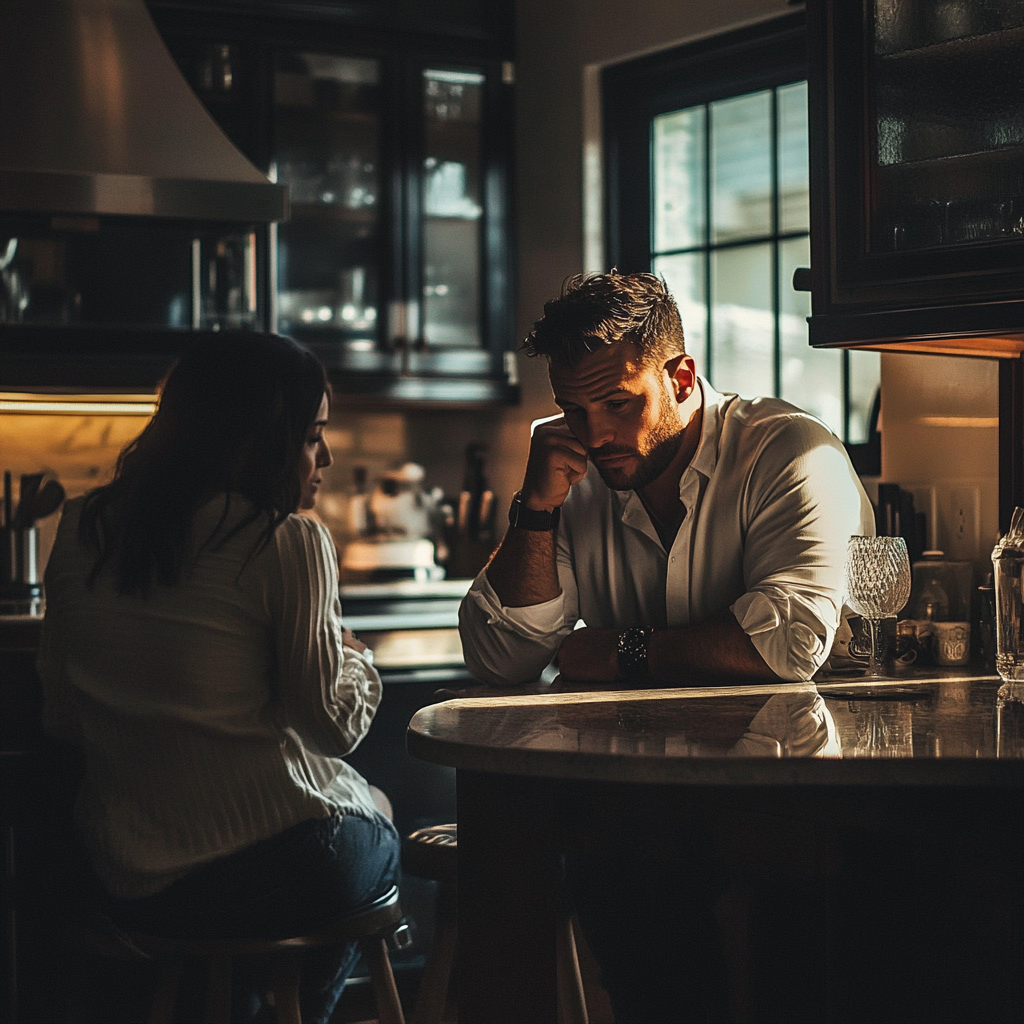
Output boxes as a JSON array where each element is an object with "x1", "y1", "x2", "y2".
[{"x1": 271, "y1": 48, "x2": 512, "y2": 398}]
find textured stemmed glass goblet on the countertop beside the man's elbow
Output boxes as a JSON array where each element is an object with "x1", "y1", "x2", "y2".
[{"x1": 846, "y1": 537, "x2": 910, "y2": 679}]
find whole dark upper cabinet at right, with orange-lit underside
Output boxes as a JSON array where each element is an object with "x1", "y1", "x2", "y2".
[{"x1": 807, "y1": 0, "x2": 1024, "y2": 356}]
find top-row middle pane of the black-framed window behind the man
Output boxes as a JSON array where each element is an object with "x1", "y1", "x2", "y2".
[{"x1": 711, "y1": 92, "x2": 771, "y2": 242}]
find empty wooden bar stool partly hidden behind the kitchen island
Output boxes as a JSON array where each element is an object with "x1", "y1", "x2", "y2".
[{"x1": 401, "y1": 824, "x2": 587, "y2": 1024}]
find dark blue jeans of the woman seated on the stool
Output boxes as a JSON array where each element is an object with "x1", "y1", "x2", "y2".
[{"x1": 109, "y1": 814, "x2": 399, "y2": 1024}]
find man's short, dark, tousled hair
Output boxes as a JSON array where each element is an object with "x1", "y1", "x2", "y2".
[{"x1": 523, "y1": 270, "x2": 686, "y2": 367}]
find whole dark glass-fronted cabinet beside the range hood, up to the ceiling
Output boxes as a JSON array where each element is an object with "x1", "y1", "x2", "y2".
[{"x1": 153, "y1": 4, "x2": 518, "y2": 404}]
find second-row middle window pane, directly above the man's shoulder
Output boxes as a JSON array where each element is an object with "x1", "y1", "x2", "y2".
[{"x1": 711, "y1": 243, "x2": 774, "y2": 396}]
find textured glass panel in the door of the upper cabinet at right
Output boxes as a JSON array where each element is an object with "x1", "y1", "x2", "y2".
[{"x1": 869, "y1": 0, "x2": 1024, "y2": 252}]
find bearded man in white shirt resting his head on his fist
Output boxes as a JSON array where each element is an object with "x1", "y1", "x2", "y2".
[{"x1": 461, "y1": 272, "x2": 874, "y2": 685}]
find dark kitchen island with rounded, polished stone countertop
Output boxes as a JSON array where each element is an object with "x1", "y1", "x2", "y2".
[{"x1": 408, "y1": 672, "x2": 1024, "y2": 1024}]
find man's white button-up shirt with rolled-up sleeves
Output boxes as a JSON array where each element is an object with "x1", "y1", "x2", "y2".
[{"x1": 460, "y1": 378, "x2": 874, "y2": 684}]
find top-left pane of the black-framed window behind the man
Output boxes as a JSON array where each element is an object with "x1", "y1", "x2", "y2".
[{"x1": 652, "y1": 106, "x2": 706, "y2": 252}]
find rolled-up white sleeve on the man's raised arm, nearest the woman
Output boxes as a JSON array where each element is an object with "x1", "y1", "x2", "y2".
[{"x1": 459, "y1": 529, "x2": 579, "y2": 686}]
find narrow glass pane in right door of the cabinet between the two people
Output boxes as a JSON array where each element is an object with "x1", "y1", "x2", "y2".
[{"x1": 423, "y1": 71, "x2": 483, "y2": 348}]
